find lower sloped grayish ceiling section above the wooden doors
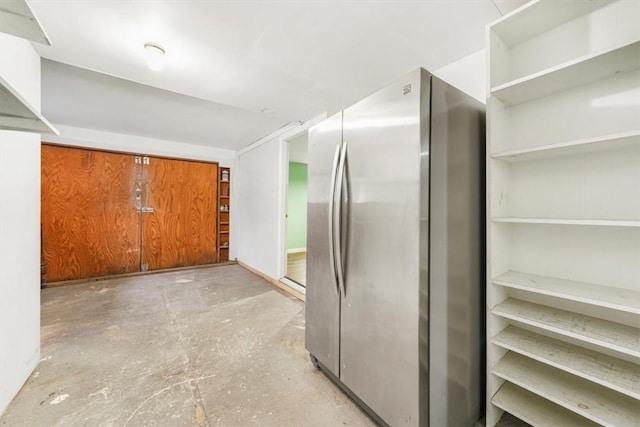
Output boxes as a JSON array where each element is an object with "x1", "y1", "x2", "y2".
[{"x1": 42, "y1": 60, "x2": 286, "y2": 149}]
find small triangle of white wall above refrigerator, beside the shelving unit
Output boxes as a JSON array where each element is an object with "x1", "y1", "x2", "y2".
[{"x1": 432, "y1": 49, "x2": 487, "y2": 104}]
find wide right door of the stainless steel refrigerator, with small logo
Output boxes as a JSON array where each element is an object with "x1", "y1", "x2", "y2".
[{"x1": 340, "y1": 70, "x2": 428, "y2": 426}]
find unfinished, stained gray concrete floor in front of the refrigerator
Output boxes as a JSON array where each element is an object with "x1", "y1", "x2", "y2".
[{"x1": 0, "y1": 265, "x2": 374, "y2": 427}]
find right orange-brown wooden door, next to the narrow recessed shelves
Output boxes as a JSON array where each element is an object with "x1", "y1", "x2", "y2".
[{"x1": 142, "y1": 157, "x2": 218, "y2": 270}]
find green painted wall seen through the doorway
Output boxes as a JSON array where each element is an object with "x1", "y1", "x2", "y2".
[{"x1": 287, "y1": 162, "x2": 307, "y2": 249}]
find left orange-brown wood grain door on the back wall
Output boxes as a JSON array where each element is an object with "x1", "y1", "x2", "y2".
[{"x1": 41, "y1": 144, "x2": 140, "y2": 282}]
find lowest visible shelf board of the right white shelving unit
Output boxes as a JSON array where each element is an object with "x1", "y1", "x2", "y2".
[{"x1": 491, "y1": 382, "x2": 599, "y2": 427}]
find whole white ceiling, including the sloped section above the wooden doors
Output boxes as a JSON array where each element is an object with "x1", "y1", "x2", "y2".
[{"x1": 28, "y1": 0, "x2": 525, "y2": 148}]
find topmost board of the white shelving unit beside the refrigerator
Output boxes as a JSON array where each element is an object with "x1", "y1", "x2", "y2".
[{"x1": 490, "y1": 0, "x2": 613, "y2": 46}]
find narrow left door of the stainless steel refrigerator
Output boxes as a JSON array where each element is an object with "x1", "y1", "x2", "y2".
[{"x1": 305, "y1": 112, "x2": 342, "y2": 376}]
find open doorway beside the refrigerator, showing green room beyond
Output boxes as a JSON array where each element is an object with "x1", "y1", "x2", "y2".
[{"x1": 286, "y1": 131, "x2": 308, "y2": 286}]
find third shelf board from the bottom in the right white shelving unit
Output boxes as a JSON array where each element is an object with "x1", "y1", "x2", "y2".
[{"x1": 491, "y1": 325, "x2": 640, "y2": 400}]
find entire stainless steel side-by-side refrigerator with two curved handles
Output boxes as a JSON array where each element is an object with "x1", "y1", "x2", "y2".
[{"x1": 306, "y1": 69, "x2": 485, "y2": 427}]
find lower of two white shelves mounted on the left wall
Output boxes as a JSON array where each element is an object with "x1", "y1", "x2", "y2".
[{"x1": 0, "y1": 77, "x2": 59, "y2": 135}]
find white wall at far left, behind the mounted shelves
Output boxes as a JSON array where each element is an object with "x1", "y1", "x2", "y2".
[{"x1": 0, "y1": 34, "x2": 40, "y2": 413}]
